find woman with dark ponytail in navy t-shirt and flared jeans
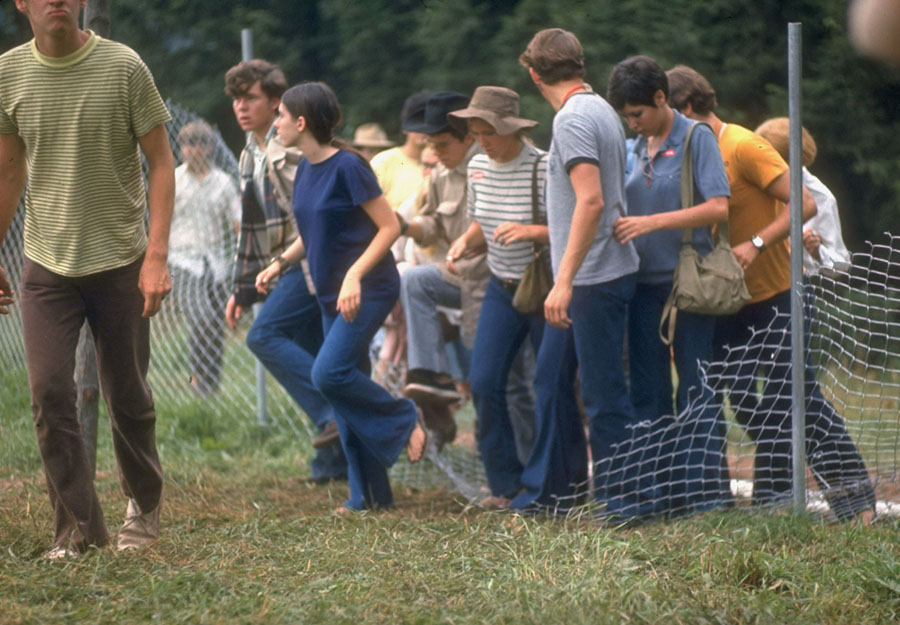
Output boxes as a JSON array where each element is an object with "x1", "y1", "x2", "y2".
[{"x1": 256, "y1": 82, "x2": 426, "y2": 512}]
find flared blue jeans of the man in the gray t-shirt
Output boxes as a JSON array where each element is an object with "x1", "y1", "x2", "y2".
[{"x1": 513, "y1": 274, "x2": 639, "y2": 514}]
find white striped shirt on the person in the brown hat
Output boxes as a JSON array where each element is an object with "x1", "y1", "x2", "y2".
[{"x1": 467, "y1": 143, "x2": 547, "y2": 280}]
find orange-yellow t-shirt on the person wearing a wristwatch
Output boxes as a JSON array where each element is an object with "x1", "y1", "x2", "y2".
[{"x1": 719, "y1": 124, "x2": 791, "y2": 303}]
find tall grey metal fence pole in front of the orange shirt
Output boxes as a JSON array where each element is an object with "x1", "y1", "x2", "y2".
[{"x1": 788, "y1": 22, "x2": 806, "y2": 514}]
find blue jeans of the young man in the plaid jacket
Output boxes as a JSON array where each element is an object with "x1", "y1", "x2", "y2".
[{"x1": 247, "y1": 266, "x2": 347, "y2": 480}]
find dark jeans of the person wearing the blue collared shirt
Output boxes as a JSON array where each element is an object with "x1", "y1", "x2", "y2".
[{"x1": 628, "y1": 283, "x2": 731, "y2": 512}]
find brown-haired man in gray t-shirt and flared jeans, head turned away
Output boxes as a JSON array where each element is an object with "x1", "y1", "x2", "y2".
[{"x1": 512, "y1": 28, "x2": 643, "y2": 517}]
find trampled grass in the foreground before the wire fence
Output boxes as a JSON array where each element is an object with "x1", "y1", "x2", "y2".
[{"x1": 0, "y1": 366, "x2": 900, "y2": 625}]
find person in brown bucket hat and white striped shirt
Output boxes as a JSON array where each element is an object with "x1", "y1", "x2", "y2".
[{"x1": 447, "y1": 86, "x2": 549, "y2": 507}]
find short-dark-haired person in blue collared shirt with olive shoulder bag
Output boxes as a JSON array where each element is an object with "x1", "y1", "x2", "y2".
[{"x1": 607, "y1": 56, "x2": 730, "y2": 511}]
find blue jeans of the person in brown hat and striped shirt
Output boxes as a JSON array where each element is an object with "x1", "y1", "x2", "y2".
[{"x1": 470, "y1": 276, "x2": 544, "y2": 497}]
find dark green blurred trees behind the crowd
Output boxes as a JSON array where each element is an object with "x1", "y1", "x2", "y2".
[{"x1": 0, "y1": 0, "x2": 900, "y2": 247}]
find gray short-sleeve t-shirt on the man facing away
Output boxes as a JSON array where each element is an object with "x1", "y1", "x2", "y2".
[{"x1": 547, "y1": 93, "x2": 638, "y2": 286}]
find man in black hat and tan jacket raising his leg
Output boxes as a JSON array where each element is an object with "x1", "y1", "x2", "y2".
[{"x1": 400, "y1": 91, "x2": 488, "y2": 404}]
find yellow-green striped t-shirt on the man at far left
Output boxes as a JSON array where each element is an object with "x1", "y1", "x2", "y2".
[{"x1": 0, "y1": 33, "x2": 169, "y2": 277}]
